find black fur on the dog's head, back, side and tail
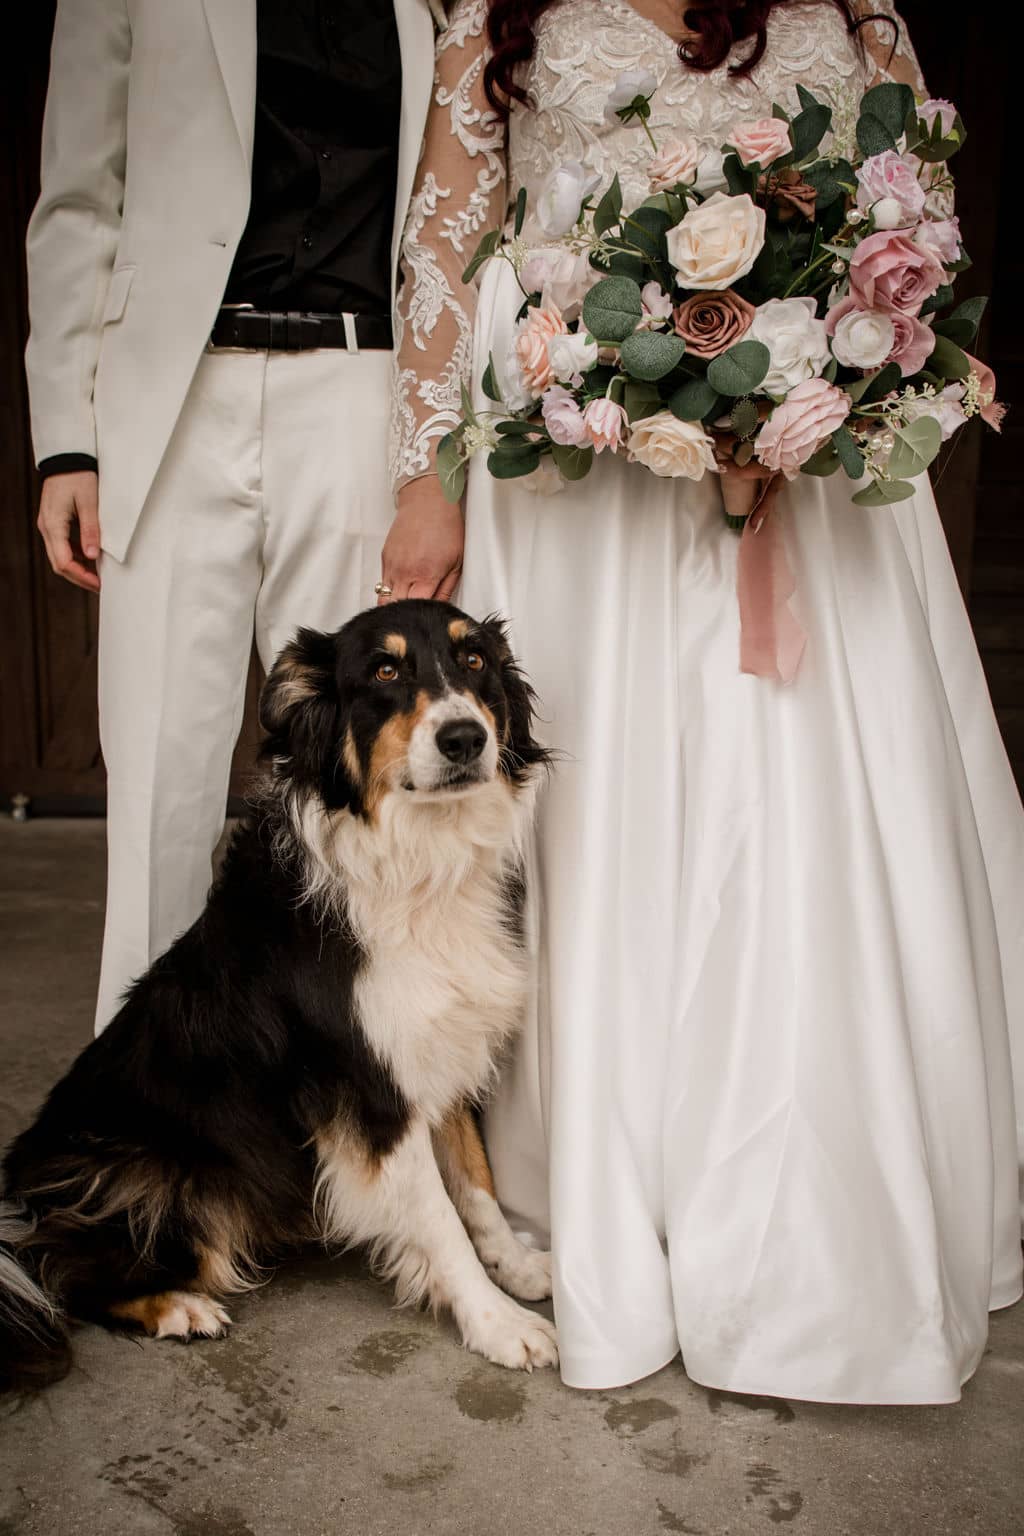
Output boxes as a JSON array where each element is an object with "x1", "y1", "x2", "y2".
[{"x1": 0, "y1": 602, "x2": 545, "y2": 1389}]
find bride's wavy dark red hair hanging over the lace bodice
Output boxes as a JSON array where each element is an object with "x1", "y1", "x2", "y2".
[{"x1": 484, "y1": 0, "x2": 895, "y2": 117}]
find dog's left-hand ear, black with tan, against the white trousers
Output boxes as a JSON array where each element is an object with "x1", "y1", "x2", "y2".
[{"x1": 259, "y1": 630, "x2": 339, "y2": 779}]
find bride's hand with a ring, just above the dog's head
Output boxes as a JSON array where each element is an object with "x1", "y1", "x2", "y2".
[{"x1": 378, "y1": 475, "x2": 465, "y2": 605}]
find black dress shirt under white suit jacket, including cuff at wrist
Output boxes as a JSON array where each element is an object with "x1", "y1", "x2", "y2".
[{"x1": 38, "y1": 0, "x2": 402, "y2": 476}]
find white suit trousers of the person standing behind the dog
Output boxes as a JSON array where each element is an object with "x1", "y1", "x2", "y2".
[{"x1": 97, "y1": 350, "x2": 391, "y2": 1031}]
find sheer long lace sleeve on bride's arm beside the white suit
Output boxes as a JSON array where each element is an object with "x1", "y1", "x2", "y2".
[{"x1": 390, "y1": 0, "x2": 507, "y2": 490}]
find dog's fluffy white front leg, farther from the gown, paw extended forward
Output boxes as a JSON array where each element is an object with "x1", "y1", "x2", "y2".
[{"x1": 316, "y1": 1121, "x2": 559, "y2": 1370}]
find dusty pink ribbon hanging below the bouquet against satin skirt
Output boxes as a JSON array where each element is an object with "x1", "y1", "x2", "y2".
[{"x1": 735, "y1": 479, "x2": 808, "y2": 682}]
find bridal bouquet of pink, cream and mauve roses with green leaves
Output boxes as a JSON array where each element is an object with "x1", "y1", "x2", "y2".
[{"x1": 438, "y1": 72, "x2": 1003, "y2": 525}]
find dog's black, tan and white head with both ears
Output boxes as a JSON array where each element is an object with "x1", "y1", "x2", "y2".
[{"x1": 259, "y1": 601, "x2": 548, "y2": 819}]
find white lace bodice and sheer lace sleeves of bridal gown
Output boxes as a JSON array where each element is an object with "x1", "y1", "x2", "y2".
[{"x1": 391, "y1": 0, "x2": 924, "y2": 488}]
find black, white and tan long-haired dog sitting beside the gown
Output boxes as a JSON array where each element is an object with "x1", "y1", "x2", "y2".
[{"x1": 0, "y1": 602, "x2": 557, "y2": 1387}]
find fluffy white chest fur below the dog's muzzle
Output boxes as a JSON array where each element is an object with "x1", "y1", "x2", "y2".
[{"x1": 313, "y1": 780, "x2": 533, "y2": 1123}]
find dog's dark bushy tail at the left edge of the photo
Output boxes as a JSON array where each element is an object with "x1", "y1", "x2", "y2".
[{"x1": 0, "y1": 1200, "x2": 71, "y2": 1392}]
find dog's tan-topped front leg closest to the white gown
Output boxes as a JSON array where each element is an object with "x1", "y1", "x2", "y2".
[{"x1": 433, "y1": 1104, "x2": 551, "y2": 1301}]
